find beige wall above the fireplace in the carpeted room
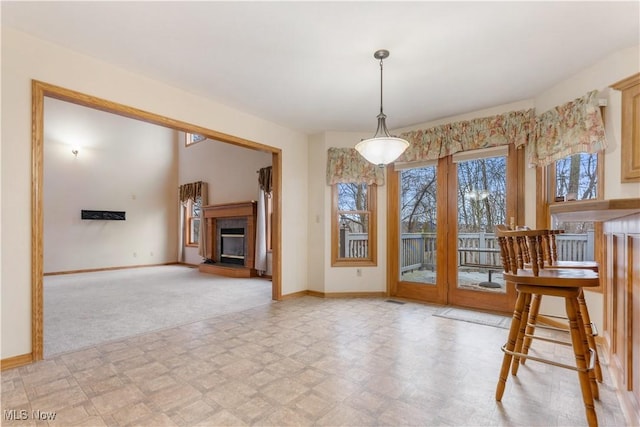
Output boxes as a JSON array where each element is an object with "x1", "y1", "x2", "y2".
[{"x1": 179, "y1": 132, "x2": 271, "y2": 264}]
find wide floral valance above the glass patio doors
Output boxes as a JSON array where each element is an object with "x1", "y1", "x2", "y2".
[{"x1": 398, "y1": 109, "x2": 534, "y2": 162}]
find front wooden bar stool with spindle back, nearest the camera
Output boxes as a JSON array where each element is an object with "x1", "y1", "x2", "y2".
[{"x1": 496, "y1": 227, "x2": 599, "y2": 426}]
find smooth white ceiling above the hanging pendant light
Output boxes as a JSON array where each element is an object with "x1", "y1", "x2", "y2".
[{"x1": 1, "y1": 1, "x2": 640, "y2": 134}]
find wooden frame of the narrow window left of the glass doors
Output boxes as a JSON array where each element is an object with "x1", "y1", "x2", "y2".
[{"x1": 331, "y1": 184, "x2": 378, "y2": 267}]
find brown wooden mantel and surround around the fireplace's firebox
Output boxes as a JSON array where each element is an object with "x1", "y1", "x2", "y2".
[{"x1": 199, "y1": 201, "x2": 257, "y2": 277}]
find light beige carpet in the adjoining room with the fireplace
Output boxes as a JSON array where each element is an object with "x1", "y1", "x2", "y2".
[{"x1": 44, "y1": 265, "x2": 271, "y2": 357}]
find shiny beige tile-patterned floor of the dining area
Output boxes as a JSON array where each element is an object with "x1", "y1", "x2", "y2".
[{"x1": 2, "y1": 297, "x2": 625, "y2": 426}]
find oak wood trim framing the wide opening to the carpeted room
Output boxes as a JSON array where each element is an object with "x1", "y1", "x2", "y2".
[{"x1": 31, "y1": 80, "x2": 282, "y2": 362}]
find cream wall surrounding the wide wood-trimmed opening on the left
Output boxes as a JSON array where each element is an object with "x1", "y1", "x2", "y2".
[{"x1": 0, "y1": 27, "x2": 308, "y2": 359}]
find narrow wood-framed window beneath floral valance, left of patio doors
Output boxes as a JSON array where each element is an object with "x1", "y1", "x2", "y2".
[{"x1": 331, "y1": 183, "x2": 377, "y2": 266}]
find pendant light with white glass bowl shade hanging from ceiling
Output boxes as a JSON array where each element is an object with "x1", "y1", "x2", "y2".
[{"x1": 356, "y1": 49, "x2": 409, "y2": 166}]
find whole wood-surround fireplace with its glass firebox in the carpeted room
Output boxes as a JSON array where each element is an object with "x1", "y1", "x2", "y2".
[{"x1": 199, "y1": 201, "x2": 257, "y2": 277}]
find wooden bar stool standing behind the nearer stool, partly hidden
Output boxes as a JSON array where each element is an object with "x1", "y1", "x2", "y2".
[{"x1": 510, "y1": 225, "x2": 602, "y2": 384}]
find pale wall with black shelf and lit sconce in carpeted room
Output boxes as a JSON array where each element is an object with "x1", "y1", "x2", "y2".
[{"x1": 43, "y1": 98, "x2": 178, "y2": 273}]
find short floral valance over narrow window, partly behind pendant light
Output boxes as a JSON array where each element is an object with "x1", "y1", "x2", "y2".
[{"x1": 327, "y1": 147, "x2": 384, "y2": 185}]
